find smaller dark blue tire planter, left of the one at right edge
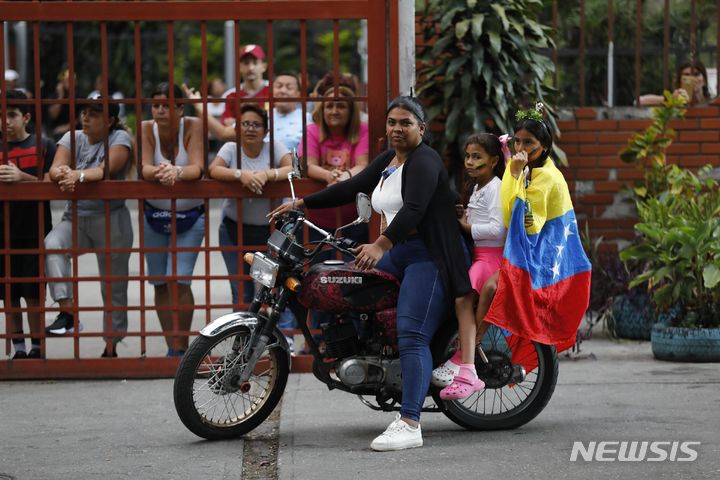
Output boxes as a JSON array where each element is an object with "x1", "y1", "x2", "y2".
[{"x1": 608, "y1": 295, "x2": 656, "y2": 340}]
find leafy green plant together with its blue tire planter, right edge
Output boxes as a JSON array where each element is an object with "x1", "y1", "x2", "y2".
[{"x1": 620, "y1": 91, "x2": 720, "y2": 361}]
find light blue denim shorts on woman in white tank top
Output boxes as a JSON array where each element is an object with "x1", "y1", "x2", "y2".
[{"x1": 144, "y1": 215, "x2": 205, "y2": 285}]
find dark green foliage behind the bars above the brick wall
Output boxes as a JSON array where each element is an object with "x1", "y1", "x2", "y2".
[{"x1": 540, "y1": 0, "x2": 718, "y2": 106}]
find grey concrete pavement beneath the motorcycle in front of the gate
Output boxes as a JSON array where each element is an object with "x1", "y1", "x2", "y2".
[{"x1": 0, "y1": 338, "x2": 720, "y2": 480}]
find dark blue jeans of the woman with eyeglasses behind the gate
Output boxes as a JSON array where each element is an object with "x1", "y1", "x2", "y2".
[{"x1": 218, "y1": 222, "x2": 270, "y2": 308}]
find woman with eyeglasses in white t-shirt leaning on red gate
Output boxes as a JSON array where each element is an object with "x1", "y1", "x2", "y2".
[{"x1": 208, "y1": 103, "x2": 292, "y2": 308}]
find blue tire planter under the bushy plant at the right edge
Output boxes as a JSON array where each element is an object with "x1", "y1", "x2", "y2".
[{"x1": 650, "y1": 325, "x2": 720, "y2": 362}]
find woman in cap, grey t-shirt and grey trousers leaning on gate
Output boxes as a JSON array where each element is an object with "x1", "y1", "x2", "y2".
[{"x1": 45, "y1": 95, "x2": 133, "y2": 357}]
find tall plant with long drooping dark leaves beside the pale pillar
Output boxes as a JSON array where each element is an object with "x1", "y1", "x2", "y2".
[{"x1": 418, "y1": 0, "x2": 567, "y2": 164}]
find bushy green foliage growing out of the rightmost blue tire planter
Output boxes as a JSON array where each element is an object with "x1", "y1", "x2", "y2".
[{"x1": 620, "y1": 165, "x2": 720, "y2": 328}]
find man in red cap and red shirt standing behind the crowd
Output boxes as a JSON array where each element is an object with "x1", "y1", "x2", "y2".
[{"x1": 221, "y1": 44, "x2": 270, "y2": 125}]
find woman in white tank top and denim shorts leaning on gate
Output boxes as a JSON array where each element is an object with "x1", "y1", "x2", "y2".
[{"x1": 142, "y1": 82, "x2": 205, "y2": 357}]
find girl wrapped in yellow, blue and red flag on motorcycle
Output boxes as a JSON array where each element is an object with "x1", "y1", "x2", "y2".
[{"x1": 477, "y1": 103, "x2": 591, "y2": 352}]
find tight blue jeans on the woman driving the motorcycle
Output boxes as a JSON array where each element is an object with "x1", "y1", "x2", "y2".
[{"x1": 377, "y1": 237, "x2": 451, "y2": 421}]
